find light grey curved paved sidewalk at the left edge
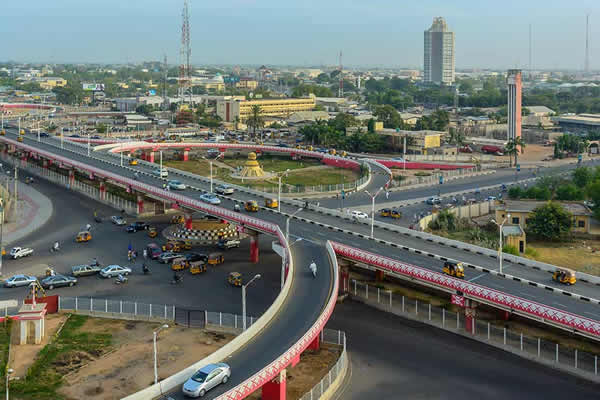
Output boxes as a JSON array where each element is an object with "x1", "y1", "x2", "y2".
[{"x1": 2, "y1": 183, "x2": 54, "y2": 248}]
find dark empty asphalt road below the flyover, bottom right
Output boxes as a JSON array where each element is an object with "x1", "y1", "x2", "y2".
[{"x1": 328, "y1": 301, "x2": 600, "y2": 400}]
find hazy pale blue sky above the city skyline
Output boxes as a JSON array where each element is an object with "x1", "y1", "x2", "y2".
[{"x1": 0, "y1": 0, "x2": 600, "y2": 69}]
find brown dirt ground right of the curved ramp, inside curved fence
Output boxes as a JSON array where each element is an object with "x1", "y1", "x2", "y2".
[{"x1": 247, "y1": 345, "x2": 341, "y2": 400}]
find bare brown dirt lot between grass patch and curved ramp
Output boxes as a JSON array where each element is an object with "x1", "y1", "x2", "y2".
[{"x1": 59, "y1": 318, "x2": 234, "y2": 400}]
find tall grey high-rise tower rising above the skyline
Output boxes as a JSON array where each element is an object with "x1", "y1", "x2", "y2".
[{"x1": 424, "y1": 17, "x2": 454, "y2": 85}]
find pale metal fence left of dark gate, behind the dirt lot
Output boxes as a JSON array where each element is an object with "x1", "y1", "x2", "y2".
[{"x1": 58, "y1": 296, "x2": 175, "y2": 321}]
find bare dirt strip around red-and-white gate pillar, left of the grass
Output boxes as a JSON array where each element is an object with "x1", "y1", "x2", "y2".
[{"x1": 9, "y1": 314, "x2": 67, "y2": 377}]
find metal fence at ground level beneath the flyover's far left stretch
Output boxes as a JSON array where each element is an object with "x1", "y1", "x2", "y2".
[{"x1": 0, "y1": 153, "x2": 137, "y2": 214}]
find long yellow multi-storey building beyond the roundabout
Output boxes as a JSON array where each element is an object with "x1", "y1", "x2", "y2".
[{"x1": 217, "y1": 97, "x2": 315, "y2": 123}]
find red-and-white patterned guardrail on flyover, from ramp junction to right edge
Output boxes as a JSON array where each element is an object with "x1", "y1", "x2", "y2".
[{"x1": 332, "y1": 242, "x2": 600, "y2": 340}]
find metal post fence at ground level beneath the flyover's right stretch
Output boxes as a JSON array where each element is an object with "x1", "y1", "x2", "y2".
[{"x1": 350, "y1": 280, "x2": 600, "y2": 381}]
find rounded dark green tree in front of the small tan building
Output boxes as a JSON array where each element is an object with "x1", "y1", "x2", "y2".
[{"x1": 527, "y1": 202, "x2": 572, "y2": 240}]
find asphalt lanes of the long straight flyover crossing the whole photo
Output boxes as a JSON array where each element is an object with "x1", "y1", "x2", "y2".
[{"x1": 7, "y1": 133, "x2": 600, "y2": 321}]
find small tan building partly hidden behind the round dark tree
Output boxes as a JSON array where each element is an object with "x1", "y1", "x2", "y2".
[{"x1": 496, "y1": 200, "x2": 592, "y2": 233}]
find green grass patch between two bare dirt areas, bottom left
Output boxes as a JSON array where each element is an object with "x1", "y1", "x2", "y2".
[{"x1": 10, "y1": 315, "x2": 112, "y2": 400}]
